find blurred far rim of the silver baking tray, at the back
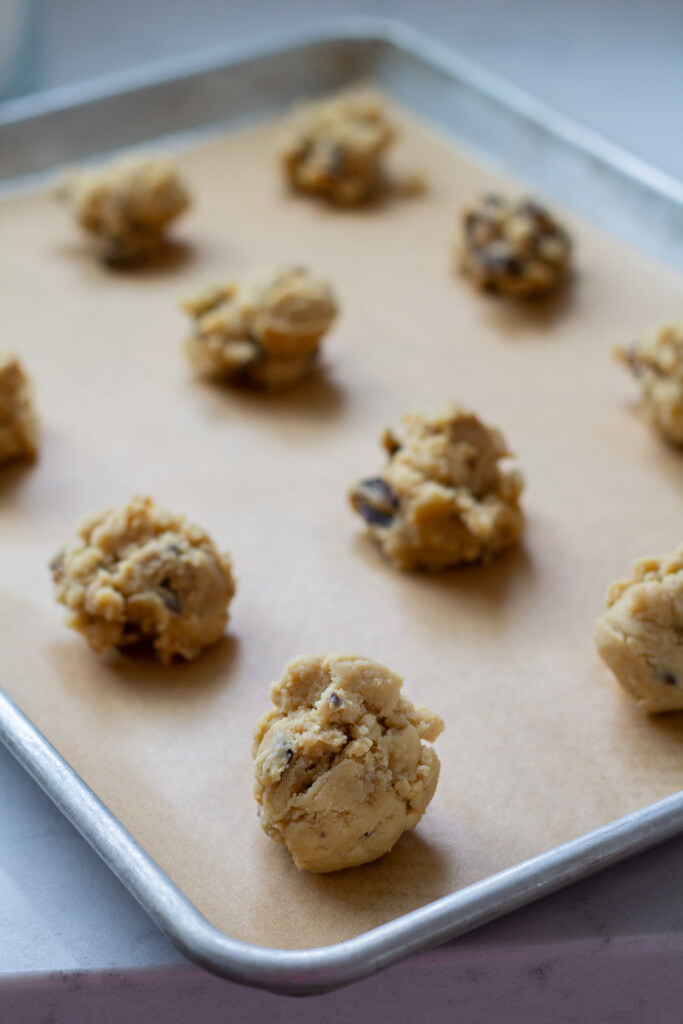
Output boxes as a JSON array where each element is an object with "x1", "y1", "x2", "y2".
[{"x1": 0, "y1": 14, "x2": 683, "y2": 208}]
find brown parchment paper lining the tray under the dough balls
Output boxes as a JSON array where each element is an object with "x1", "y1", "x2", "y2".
[{"x1": 0, "y1": 108, "x2": 683, "y2": 947}]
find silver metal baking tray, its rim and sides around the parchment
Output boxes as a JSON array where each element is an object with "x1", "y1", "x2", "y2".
[{"x1": 0, "y1": 18, "x2": 683, "y2": 994}]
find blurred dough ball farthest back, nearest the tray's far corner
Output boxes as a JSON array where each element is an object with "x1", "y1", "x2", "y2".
[{"x1": 282, "y1": 92, "x2": 394, "y2": 206}]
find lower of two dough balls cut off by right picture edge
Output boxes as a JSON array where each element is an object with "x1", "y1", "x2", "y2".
[{"x1": 594, "y1": 545, "x2": 683, "y2": 715}]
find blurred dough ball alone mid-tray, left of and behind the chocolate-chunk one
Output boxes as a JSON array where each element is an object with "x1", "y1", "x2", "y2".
[{"x1": 183, "y1": 266, "x2": 337, "y2": 391}]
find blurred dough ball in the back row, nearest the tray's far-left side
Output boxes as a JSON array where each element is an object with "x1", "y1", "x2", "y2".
[{"x1": 58, "y1": 156, "x2": 189, "y2": 264}]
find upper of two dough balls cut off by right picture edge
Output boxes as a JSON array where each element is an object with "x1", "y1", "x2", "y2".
[{"x1": 614, "y1": 323, "x2": 683, "y2": 445}]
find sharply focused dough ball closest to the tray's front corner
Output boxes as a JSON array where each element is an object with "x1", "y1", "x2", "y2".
[{"x1": 253, "y1": 654, "x2": 443, "y2": 872}]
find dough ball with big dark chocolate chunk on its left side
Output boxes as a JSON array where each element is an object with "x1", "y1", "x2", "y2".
[{"x1": 350, "y1": 402, "x2": 524, "y2": 569}]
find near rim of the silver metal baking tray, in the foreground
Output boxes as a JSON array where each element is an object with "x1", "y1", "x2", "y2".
[{"x1": 0, "y1": 688, "x2": 683, "y2": 995}]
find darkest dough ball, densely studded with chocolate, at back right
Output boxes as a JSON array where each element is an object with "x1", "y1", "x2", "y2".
[{"x1": 458, "y1": 196, "x2": 571, "y2": 299}]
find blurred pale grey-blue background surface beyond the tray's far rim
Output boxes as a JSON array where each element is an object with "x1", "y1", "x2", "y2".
[{"x1": 21, "y1": 0, "x2": 683, "y2": 178}]
